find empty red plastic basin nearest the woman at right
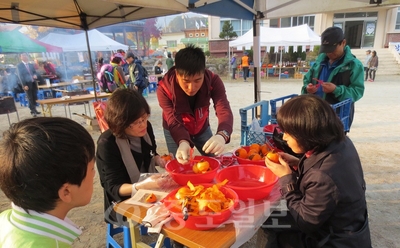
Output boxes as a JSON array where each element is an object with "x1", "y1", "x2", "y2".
[{"x1": 215, "y1": 164, "x2": 278, "y2": 201}]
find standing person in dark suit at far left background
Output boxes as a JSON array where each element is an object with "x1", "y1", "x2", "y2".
[{"x1": 17, "y1": 53, "x2": 40, "y2": 117}]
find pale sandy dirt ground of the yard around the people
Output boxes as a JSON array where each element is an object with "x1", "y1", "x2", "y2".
[{"x1": 0, "y1": 75, "x2": 400, "y2": 248}]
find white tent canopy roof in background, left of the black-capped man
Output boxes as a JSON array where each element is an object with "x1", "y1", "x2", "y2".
[{"x1": 229, "y1": 24, "x2": 321, "y2": 47}]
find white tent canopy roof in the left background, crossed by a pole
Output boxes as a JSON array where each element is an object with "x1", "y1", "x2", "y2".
[{"x1": 40, "y1": 29, "x2": 128, "y2": 52}]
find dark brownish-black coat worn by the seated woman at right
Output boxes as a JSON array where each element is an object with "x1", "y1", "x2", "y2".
[{"x1": 279, "y1": 137, "x2": 371, "y2": 248}]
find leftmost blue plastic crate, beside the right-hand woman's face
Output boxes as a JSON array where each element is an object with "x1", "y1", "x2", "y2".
[{"x1": 239, "y1": 100, "x2": 272, "y2": 146}]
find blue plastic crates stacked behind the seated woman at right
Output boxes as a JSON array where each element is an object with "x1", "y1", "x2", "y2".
[{"x1": 239, "y1": 94, "x2": 352, "y2": 146}]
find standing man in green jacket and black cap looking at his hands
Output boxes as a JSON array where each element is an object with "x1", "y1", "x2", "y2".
[{"x1": 301, "y1": 27, "x2": 364, "y2": 128}]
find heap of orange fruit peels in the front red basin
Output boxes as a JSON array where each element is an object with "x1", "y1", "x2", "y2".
[{"x1": 174, "y1": 180, "x2": 234, "y2": 216}]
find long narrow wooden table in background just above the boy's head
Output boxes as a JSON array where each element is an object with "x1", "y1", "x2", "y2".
[{"x1": 36, "y1": 93, "x2": 111, "y2": 118}]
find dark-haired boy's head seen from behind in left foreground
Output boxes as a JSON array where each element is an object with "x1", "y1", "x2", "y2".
[{"x1": 0, "y1": 117, "x2": 95, "y2": 212}]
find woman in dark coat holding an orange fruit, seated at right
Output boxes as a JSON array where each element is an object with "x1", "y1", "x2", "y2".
[{"x1": 257, "y1": 94, "x2": 371, "y2": 248}]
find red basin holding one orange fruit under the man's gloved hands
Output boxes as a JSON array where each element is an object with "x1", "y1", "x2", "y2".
[{"x1": 165, "y1": 156, "x2": 220, "y2": 186}]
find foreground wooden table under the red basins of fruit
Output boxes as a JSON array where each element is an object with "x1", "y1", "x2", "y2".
[{"x1": 114, "y1": 187, "x2": 280, "y2": 248}]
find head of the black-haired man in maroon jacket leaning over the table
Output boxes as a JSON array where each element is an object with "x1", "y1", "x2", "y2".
[{"x1": 175, "y1": 44, "x2": 206, "y2": 96}]
